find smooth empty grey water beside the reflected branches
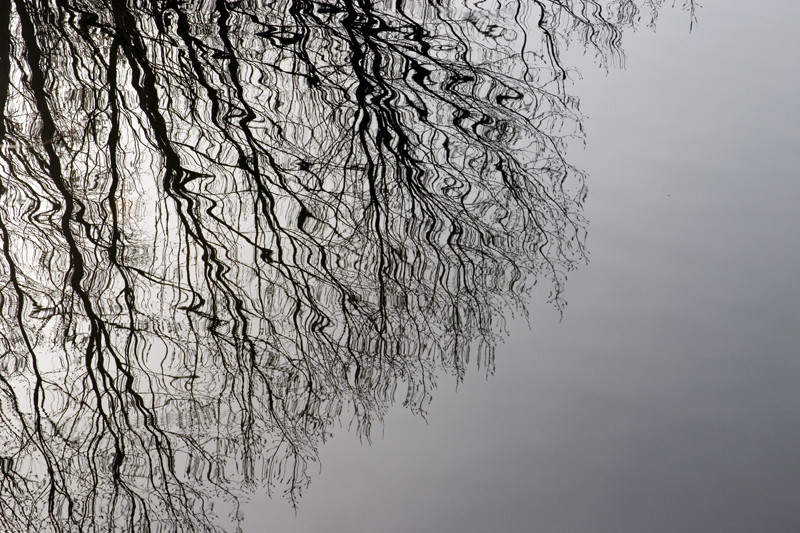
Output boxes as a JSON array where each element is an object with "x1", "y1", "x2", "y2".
[{"x1": 244, "y1": 0, "x2": 800, "y2": 533}]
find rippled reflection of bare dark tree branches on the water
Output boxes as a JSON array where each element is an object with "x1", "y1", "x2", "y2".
[{"x1": 0, "y1": 0, "x2": 688, "y2": 532}]
